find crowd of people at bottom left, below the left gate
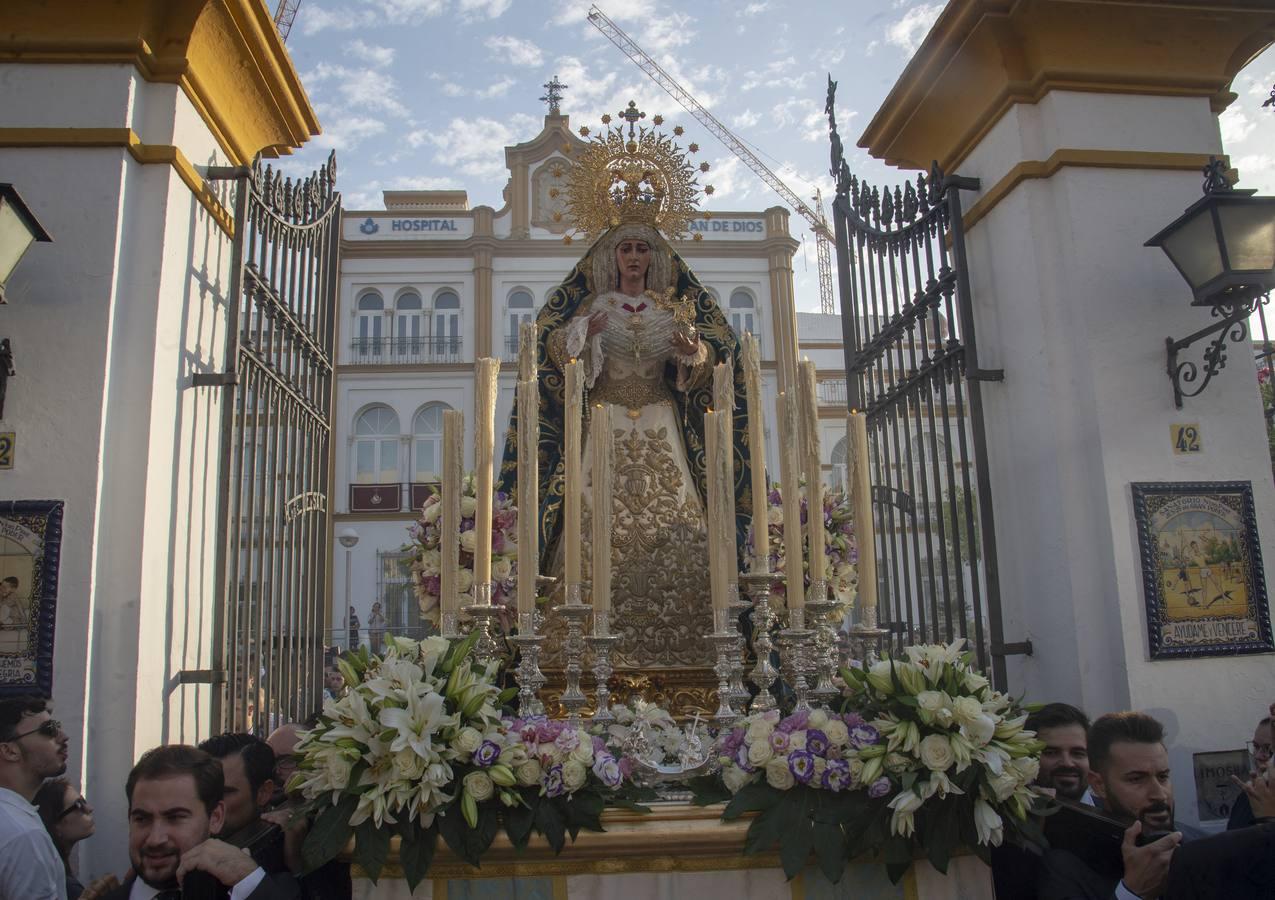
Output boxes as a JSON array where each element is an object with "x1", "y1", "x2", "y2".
[{"x1": 0, "y1": 696, "x2": 352, "y2": 900}]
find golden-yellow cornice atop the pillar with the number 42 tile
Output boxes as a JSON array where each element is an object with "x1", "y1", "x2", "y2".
[{"x1": 859, "y1": 0, "x2": 1275, "y2": 171}]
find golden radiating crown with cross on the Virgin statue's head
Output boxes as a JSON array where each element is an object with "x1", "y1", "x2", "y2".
[{"x1": 564, "y1": 101, "x2": 713, "y2": 243}]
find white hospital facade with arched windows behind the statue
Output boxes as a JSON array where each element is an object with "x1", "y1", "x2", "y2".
[{"x1": 332, "y1": 115, "x2": 797, "y2": 645}]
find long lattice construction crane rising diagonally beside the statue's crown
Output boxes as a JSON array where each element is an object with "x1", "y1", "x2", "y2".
[{"x1": 589, "y1": 6, "x2": 836, "y2": 314}]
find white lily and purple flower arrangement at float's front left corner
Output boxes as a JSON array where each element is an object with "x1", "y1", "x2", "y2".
[{"x1": 288, "y1": 634, "x2": 649, "y2": 890}]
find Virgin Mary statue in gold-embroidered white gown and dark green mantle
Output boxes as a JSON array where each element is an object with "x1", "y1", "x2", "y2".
[{"x1": 500, "y1": 105, "x2": 751, "y2": 674}]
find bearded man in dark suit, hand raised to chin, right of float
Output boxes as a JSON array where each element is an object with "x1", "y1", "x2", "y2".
[{"x1": 1038, "y1": 713, "x2": 1199, "y2": 900}]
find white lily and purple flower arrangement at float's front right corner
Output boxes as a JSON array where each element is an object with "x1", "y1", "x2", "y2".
[{"x1": 691, "y1": 641, "x2": 1042, "y2": 882}]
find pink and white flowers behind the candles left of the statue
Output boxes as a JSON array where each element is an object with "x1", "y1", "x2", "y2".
[{"x1": 404, "y1": 473, "x2": 518, "y2": 623}]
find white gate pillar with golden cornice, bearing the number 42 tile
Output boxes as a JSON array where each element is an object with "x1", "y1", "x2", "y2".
[{"x1": 859, "y1": 0, "x2": 1275, "y2": 820}]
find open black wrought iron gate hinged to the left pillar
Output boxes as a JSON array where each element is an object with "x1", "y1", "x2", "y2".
[{"x1": 196, "y1": 156, "x2": 340, "y2": 733}]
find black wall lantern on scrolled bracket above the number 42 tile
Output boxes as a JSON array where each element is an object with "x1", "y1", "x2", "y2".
[{"x1": 1144, "y1": 157, "x2": 1275, "y2": 409}]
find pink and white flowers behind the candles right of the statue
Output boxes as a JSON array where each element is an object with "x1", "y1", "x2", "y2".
[{"x1": 745, "y1": 482, "x2": 859, "y2": 621}]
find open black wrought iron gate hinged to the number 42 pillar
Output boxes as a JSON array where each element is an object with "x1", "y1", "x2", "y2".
[{"x1": 826, "y1": 79, "x2": 1025, "y2": 687}]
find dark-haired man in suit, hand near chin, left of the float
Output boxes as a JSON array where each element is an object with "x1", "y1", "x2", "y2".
[{"x1": 96, "y1": 744, "x2": 297, "y2": 900}]
